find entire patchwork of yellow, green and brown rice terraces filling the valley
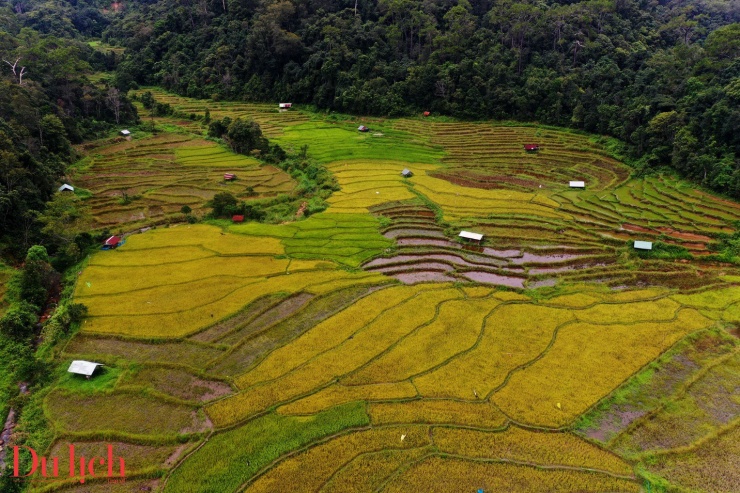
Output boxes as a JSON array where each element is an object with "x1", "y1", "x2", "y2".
[{"x1": 31, "y1": 88, "x2": 740, "y2": 493}]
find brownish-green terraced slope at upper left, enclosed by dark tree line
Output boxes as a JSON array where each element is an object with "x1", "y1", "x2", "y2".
[{"x1": 71, "y1": 133, "x2": 295, "y2": 232}]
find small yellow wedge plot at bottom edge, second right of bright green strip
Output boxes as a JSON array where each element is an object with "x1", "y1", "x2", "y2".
[{"x1": 321, "y1": 448, "x2": 429, "y2": 493}]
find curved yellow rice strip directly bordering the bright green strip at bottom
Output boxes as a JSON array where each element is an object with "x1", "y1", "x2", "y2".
[{"x1": 247, "y1": 426, "x2": 429, "y2": 493}]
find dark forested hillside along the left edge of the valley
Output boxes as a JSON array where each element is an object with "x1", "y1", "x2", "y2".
[{"x1": 0, "y1": 18, "x2": 137, "y2": 259}]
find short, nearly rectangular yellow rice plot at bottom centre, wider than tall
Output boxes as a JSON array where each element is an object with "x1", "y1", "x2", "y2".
[{"x1": 368, "y1": 399, "x2": 506, "y2": 428}]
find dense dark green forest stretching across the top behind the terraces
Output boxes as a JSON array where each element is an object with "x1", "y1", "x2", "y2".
[{"x1": 103, "y1": 0, "x2": 740, "y2": 197}]
